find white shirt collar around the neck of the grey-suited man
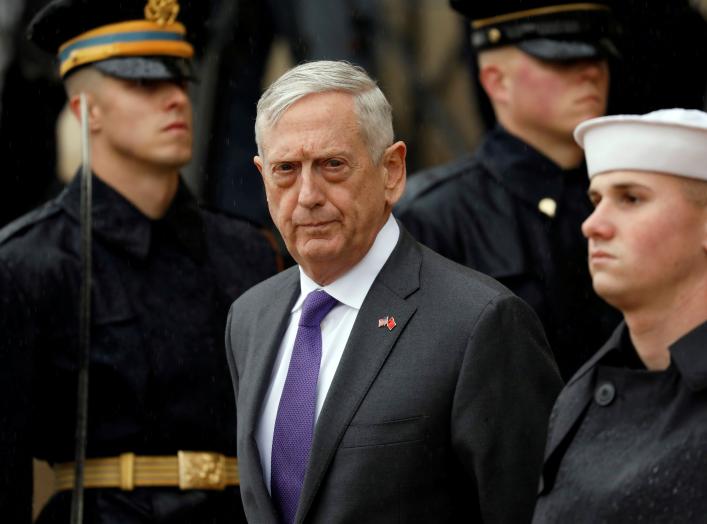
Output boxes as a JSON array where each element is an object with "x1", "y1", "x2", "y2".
[{"x1": 292, "y1": 214, "x2": 400, "y2": 312}]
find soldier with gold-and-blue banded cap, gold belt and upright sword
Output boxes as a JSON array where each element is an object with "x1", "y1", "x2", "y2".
[{"x1": 0, "y1": 0, "x2": 275, "y2": 524}]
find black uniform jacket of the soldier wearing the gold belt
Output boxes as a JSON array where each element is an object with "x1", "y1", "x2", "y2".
[{"x1": 0, "y1": 177, "x2": 275, "y2": 522}]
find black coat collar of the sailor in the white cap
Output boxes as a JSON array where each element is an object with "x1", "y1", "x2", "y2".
[{"x1": 598, "y1": 322, "x2": 707, "y2": 391}]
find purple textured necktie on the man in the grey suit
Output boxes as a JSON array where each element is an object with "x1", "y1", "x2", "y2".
[{"x1": 270, "y1": 289, "x2": 337, "y2": 524}]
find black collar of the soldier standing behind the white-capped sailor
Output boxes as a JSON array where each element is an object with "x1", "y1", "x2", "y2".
[{"x1": 478, "y1": 124, "x2": 588, "y2": 209}]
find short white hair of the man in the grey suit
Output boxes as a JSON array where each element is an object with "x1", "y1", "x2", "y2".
[{"x1": 255, "y1": 60, "x2": 393, "y2": 163}]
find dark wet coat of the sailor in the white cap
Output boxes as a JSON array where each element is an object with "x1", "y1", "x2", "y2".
[{"x1": 533, "y1": 322, "x2": 707, "y2": 524}]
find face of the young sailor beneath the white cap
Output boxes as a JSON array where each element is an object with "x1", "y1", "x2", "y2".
[{"x1": 582, "y1": 171, "x2": 707, "y2": 313}]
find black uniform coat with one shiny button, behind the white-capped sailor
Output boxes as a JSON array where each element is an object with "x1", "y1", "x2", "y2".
[{"x1": 395, "y1": 126, "x2": 620, "y2": 380}]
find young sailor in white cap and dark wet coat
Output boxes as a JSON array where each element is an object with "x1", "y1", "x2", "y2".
[{"x1": 533, "y1": 109, "x2": 707, "y2": 524}]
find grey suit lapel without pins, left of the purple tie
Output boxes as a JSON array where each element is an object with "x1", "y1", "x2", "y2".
[{"x1": 238, "y1": 267, "x2": 300, "y2": 522}]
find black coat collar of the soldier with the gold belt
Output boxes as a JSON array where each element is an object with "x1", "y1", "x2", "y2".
[{"x1": 58, "y1": 175, "x2": 205, "y2": 261}]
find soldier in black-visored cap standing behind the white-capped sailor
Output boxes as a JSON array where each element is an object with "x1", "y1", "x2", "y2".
[{"x1": 396, "y1": 0, "x2": 619, "y2": 379}]
